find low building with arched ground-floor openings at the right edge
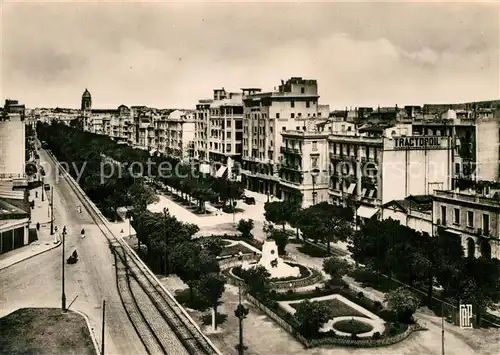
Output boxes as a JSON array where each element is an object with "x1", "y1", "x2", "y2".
[{"x1": 433, "y1": 189, "x2": 500, "y2": 259}]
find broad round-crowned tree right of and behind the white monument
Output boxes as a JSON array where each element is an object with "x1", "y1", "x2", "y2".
[{"x1": 300, "y1": 202, "x2": 352, "y2": 252}]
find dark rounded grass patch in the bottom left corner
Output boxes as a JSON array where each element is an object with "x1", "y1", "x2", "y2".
[{"x1": 0, "y1": 308, "x2": 96, "y2": 355}]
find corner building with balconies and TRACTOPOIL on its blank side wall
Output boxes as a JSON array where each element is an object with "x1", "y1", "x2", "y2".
[{"x1": 280, "y1": 122, "x2": 453, "y2": 225}]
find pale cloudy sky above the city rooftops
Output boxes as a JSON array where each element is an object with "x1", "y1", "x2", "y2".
[{"x1": 0, "y1": 1, "x2": 500, "y2": 109}]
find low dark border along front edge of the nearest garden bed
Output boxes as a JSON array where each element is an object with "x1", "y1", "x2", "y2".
[{"x1": 245, "y1": 293, "x2": 421, "y2": 348}]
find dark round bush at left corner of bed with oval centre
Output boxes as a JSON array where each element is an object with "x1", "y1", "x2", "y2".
[{"x1": 294, "y1": 300, "x2": 331, "y2": 337}]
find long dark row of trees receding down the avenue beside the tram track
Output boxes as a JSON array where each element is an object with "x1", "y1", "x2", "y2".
[{"x1": 37, "y1": 122, "x2": 243, "y2": 217}]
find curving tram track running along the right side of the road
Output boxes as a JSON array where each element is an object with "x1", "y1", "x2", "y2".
[{"x1": 49, "y1": 153, "x2": 221, "y2": 355}]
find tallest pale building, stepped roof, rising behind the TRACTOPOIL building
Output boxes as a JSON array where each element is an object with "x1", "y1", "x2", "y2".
[{"x1": 242, "y1": 77, "x2": 329, "y2": 197}]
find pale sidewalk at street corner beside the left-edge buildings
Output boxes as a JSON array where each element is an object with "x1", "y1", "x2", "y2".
[{"x1": 0, "y1": 187, "x2": 61, "y2": 270}]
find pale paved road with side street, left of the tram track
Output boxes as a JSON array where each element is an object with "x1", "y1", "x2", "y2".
[{"x1": 0, "y1": 151, "x2": 146, "y2": 355}]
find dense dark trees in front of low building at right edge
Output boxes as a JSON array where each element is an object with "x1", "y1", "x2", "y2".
[{"x1": 349, "y1": 219, "x2": 500, "y2": 324}]
